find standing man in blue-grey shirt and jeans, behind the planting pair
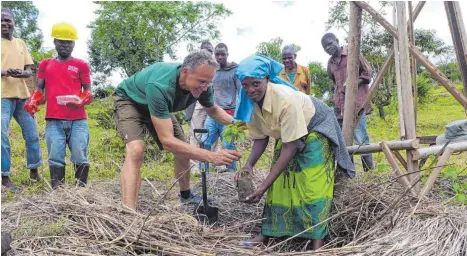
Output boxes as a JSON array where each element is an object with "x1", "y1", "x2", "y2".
[{"x1": 201, "y1": 43, "x2": 242, "y2": 172}]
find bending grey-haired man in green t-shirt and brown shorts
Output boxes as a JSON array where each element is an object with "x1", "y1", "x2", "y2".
[{"x1": 114, "y1": 50, "x2": 240, "y2": 210}]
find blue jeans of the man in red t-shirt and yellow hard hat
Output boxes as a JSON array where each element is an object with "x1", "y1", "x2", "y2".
[{"x1": 45, "y1": 119, "x2": 89, "y2": 167}]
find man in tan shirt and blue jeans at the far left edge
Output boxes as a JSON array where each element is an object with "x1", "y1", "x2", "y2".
[{"x1": 1, "y1": 9, "x2": 42, "y2": 192}]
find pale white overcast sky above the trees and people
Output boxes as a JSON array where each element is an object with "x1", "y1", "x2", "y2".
[{"x1": 33, "y1": 0, "x2": 467, "y2": 84}]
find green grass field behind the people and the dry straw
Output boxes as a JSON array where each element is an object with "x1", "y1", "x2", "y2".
[{"x1": 6, "y1": 85, "x2": 467, "y2": 204}]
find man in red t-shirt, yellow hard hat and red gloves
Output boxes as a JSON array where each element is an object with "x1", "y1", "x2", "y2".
[{"x1": 24, "y1": 23, "x2": 92, "y2": 188}]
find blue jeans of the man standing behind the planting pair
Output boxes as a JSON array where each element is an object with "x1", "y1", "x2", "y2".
[{"x1": 201, "y1": 116, "x2": 237, "y2": 170}]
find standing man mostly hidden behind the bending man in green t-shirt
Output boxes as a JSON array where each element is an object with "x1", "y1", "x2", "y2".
[{"x1": 186, "y1": 41, "x2": 214, "y2": 173}]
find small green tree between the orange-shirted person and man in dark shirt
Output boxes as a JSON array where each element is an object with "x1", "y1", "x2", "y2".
[{"x1": 308, "y1": 62, "x2": 333, "y2": 100}]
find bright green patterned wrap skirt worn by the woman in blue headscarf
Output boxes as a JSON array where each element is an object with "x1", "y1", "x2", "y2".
[{"x1": 261, "y1": 132, "x2": 335, "y2": 240}]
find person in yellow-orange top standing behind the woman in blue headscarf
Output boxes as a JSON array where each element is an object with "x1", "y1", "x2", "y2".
[{"x1": 279, "y1": 45, "x2": 312, "y2": 95}]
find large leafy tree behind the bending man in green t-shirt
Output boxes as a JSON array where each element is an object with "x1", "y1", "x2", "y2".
[{"x1": 88, "y1": 1, "x2": 231, "y2": 76}]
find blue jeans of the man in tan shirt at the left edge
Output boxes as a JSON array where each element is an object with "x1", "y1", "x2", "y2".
[{"x1": 2, "y1": 99, "x2": 42, "y2": 176}]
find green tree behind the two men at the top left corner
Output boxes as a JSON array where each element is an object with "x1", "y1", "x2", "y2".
[{"x1": 2, "y1": 1, "x2": 54, "y2": 64}]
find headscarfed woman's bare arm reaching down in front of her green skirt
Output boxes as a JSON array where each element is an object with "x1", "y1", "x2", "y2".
[{"x1": 246, "y1": 140, "x2": 297, "y2": 203}]
